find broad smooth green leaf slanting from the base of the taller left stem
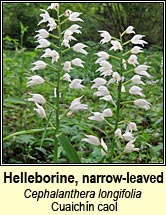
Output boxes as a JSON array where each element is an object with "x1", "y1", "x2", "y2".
[{"x1": 57, "y1": 133, "x2": 81, "y2": 163}]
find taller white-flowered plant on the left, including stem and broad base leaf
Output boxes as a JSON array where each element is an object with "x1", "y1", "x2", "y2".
[{"x1": 27, "y1": 3, "x2": 88, "y2": 162}]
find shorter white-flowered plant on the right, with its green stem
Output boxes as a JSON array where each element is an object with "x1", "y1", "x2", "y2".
[{"x1": 82, "y1": 26, "x2": 151, "y2": 162}]
